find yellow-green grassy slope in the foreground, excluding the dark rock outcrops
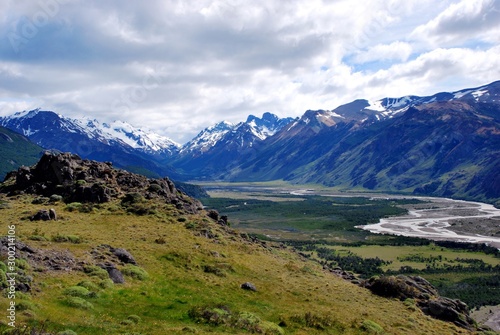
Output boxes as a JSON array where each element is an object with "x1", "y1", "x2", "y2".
[{"x1": 0, "y1": 195, "x2": 476, "y2": 335}]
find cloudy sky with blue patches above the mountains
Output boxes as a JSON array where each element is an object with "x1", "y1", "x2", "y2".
[{"x1": 0, "y1": 0, "x2": 500, "y2": 143}]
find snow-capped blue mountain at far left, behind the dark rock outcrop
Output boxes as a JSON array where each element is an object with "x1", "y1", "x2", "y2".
[{"x1": 0, "y1": 109, "x2": 180, "y2": 175}]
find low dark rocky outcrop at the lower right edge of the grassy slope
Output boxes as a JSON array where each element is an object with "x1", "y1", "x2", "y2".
[{"x1": 363, "y1": 275, "x2": 476, "y2": 330}]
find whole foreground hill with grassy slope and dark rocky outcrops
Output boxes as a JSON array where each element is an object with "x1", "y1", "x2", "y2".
[{"x1": 0, "y1": 153, "x2": 484, "y2": 335}]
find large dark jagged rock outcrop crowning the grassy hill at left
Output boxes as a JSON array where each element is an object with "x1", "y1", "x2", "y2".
[{"x1": 0, "y1": 152, "x2": 202, "y2": 213}]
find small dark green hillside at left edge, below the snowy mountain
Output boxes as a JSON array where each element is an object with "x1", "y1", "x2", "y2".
[{"x1": 0, "y1": 127, "x2": 43, "y2": 180}]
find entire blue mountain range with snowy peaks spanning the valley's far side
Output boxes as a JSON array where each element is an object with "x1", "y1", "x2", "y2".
[{"x1": 0, "y1": 81, "x2": 500, "y2": 202}]
